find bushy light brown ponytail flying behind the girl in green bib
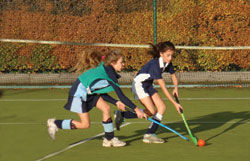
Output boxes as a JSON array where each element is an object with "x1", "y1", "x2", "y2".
[{"x1": 71, "y1": 49, "x2": 103, "y2": 73}]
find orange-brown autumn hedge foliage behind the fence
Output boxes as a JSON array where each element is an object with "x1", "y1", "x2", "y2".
[{"x1": 0, "y1": 0, "x2": 250, "y2": 71}]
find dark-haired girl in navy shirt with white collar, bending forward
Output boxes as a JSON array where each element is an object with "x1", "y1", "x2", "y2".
[{"x1": 115, "y1": 41, "x2": 182, "y2": 143}]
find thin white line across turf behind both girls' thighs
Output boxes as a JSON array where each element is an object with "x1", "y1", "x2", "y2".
[{"x1": 0, "y1": 97, "x2": 250, "y2": 102}]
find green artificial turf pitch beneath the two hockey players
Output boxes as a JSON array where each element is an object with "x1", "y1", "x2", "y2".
[{"x1": 0, "y1": 88, "x2": 250, "y2": 161}]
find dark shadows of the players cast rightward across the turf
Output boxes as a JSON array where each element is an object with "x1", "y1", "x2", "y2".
[{"x1": 113, "y1": 111, "x2": 250, "y2": 145}]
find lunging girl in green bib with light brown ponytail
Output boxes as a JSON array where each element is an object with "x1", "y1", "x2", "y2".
[{"x1": 47, "y1": 50, "x2": 146, "y2": 147}]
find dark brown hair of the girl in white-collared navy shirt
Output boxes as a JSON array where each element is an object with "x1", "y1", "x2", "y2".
[{"x1": 148, "y1": 41, "x2": 175, "y2": 58}]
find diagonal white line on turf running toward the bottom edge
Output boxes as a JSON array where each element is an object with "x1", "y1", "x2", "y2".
[{"x1": 36, "y1": 123, "x2": 130, "y2": 161}]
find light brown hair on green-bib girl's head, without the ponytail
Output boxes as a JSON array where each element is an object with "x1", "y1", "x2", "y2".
[{"x1": 103, "y1": 50, "x2": 123, "y2": 66}]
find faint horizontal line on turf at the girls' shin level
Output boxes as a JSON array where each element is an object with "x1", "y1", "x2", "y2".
[{"x1": 0, "y1": 121, "x2": 250, "y2": 125}]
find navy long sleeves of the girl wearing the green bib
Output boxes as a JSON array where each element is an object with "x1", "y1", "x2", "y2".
[{"x1": 101, "y1": 66, "x2": 136, "y2": 109}]
